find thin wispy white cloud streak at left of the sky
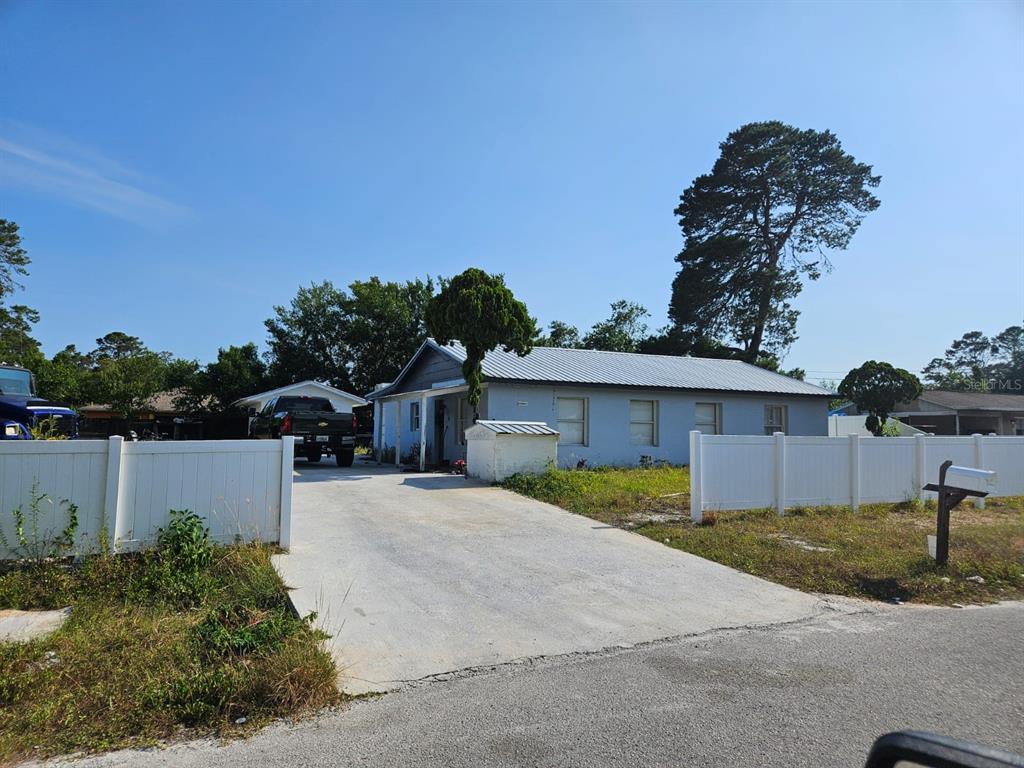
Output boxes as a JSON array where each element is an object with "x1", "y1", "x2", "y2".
[{"x1": 0, "y1": 121, "x2": 189, "y2": 225}]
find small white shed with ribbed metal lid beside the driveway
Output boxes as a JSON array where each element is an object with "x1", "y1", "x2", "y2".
[{"x1": 466, "y1": 420, "x2": 558, "y2": 482}]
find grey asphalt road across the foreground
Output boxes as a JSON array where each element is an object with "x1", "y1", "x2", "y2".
[{"x1": 64, "y1": 603, "x2": 1024, "y2": 768}]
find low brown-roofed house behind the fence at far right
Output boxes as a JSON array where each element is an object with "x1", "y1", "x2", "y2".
[{"x1": 892, "y1": 390, "x2": 1024, "y2": 435}]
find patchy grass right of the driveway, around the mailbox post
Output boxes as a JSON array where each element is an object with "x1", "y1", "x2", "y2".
[{"x1": 505, "y1": 467, "x2": 1024, "y2": 604}]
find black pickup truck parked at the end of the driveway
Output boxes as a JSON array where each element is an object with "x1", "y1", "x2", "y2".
[{"x1": 249, "y1": 395, "x2": 355, "y2": 467}]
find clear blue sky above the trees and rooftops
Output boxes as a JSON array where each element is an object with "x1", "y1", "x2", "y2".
[{"x1": 0, "y1": 0, "x2": 1024, "y2": 385}]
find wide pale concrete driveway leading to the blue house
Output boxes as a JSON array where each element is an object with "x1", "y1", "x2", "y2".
[{"x1": 274, "y1": 461, "x2": 826, "y2": 693}]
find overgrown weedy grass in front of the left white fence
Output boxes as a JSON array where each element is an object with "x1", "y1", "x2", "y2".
[{"x1": 0, "y1": 517, "x2": 339, "y2": 764}]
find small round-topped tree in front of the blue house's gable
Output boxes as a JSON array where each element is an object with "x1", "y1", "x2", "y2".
[{"x1": 427, "y1": 267, "x2": 538, "y2": 412}]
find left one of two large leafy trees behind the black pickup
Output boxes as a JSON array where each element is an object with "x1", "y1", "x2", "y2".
[{"x1": 264, "y1": 281, "x2": 352, "y2": 390}]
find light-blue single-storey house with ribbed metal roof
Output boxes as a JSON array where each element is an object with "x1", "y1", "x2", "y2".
[{"x1": 367, "y1": 340, "x2": 835, "y2": 466}]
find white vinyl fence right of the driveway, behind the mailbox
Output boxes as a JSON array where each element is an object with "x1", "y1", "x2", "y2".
[{"x1": 690, "y1": 431, "x2": 1024, "y2": 521}]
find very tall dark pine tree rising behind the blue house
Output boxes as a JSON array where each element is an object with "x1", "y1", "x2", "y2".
[{"x1": 670, "y1": 121, "x2": 881, "y2": 362}]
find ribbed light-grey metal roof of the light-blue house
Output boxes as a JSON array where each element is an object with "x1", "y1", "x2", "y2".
[{"x1": 369, "y1": 339, "x2": 835, "y2": 399}]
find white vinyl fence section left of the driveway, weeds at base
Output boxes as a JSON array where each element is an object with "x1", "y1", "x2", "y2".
[{"x1": 0, "y1": 437, "x2": 295, "y2": 558}]
